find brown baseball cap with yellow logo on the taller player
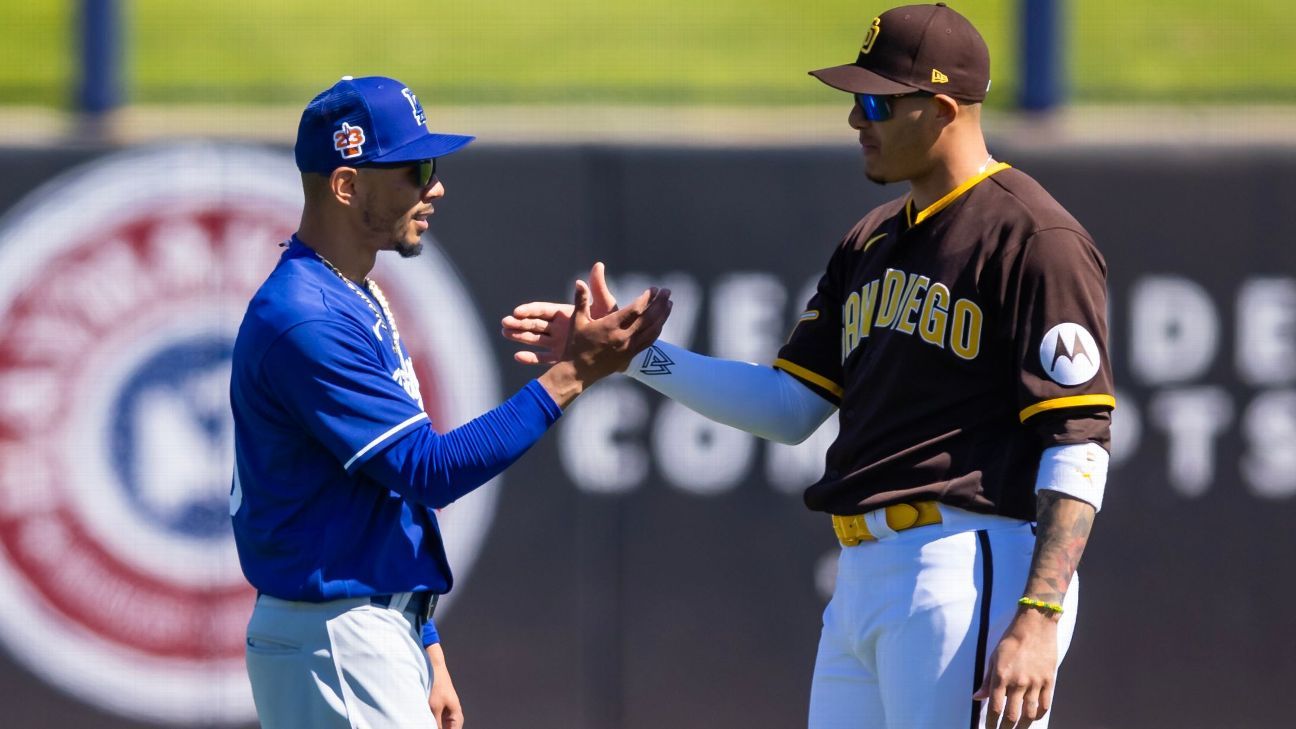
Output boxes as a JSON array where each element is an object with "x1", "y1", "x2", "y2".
[{"x1": 810, "y1": 3, "x2": 990, "y2": 101}]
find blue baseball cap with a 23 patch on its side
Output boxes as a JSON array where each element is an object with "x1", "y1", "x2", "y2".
[{"x1": 293, "y1": 77, "x2": 477, "y2": 175}]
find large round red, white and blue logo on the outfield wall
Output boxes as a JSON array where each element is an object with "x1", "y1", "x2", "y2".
[{"x1": 0, "y1": 142, "x2": 500, "y2": 726}]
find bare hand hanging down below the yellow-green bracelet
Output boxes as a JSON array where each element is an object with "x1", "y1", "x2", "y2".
[{"x1": 972, "y1": 607, "x2": 1058, "y2": 729}]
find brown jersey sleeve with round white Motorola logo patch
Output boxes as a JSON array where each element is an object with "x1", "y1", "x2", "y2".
[{"x1": 1004, "y1": 228, "x2": 1116, "y2": 448}]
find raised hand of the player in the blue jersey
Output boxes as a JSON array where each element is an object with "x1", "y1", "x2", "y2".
[{"x1": 560, "y1": 273, "x2": 671, "y2": 385}]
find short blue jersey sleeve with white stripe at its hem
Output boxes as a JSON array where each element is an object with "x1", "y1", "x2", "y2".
[{"x1": 262, "y1": 320, "x2": 428, "y2": 473}]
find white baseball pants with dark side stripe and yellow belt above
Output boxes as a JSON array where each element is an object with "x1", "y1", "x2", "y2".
[{"x1": 810, "y1": 505, "x2": 1080, "y2": 729}]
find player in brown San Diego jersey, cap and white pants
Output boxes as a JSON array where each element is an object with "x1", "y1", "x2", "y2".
[{"x1": 504, "y1": 3, "x2": 1115, "y2": 729}]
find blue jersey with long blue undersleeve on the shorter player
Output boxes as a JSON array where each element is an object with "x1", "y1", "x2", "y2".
[{"x1": 231, "y1": 236, "x2": 561, "y2": 617}]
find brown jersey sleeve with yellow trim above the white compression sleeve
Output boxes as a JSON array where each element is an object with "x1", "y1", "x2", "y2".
[{"x1": 774, "y1": 245, "x2": 846, "y2": 405}]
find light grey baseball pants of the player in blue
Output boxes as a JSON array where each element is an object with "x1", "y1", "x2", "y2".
[{"x1": 245, "y1": 595, "x2": 437, "y2": 729}]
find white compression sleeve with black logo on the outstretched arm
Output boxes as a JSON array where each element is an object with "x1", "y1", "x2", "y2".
[{"x1": 626, "y1": 341, "x2": 837, "y2": 444}]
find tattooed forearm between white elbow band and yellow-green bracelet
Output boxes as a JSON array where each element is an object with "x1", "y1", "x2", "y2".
[{"x1": 1026, "y1": 490, "x2": 1094, "y2": 603}]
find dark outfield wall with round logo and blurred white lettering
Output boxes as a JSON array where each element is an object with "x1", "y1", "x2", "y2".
[{"x1": 0, "y1": 143, "x2": 1296, "y2": 729}]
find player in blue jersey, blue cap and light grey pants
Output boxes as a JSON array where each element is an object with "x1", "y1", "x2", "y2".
[{"x1": 229, "y1": 77, "x2": 670, "y2": 729}]
